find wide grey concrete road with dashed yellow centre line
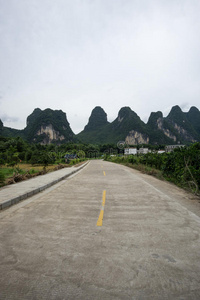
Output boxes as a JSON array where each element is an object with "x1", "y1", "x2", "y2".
[{"x1": 0, "y1": 161, "x2": 200, "y2": 300}]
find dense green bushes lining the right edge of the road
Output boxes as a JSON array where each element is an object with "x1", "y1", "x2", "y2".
[{"x1": 106, "y1": 143, "x2": 200, "y2": 194}]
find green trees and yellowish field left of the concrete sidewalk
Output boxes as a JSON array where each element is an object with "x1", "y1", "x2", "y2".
[{"x1": 0, "y1": 137, "x2": 91, "y2": 186}]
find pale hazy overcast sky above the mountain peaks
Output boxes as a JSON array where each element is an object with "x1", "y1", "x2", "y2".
[{"x1": 0, "y1": 0, "x2": 200, "y2": 133}]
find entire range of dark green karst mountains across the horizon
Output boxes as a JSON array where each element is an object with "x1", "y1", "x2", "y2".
[{"x1": 0, "y1": 105, "x2": 200, "y2": 145}]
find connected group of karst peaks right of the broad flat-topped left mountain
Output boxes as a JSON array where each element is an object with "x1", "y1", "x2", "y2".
[{"x1": 76, "y1": 106, "x2": 200, "y2": 145}]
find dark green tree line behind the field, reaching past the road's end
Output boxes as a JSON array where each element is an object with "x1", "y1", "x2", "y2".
[{"x1": 0, "y1": 137, "x2": 120, "y2": 166}]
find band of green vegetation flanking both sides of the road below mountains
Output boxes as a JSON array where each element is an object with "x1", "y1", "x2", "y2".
[{"x1": 0, "y1": 137, "x2": 200, "y2": 194}]
